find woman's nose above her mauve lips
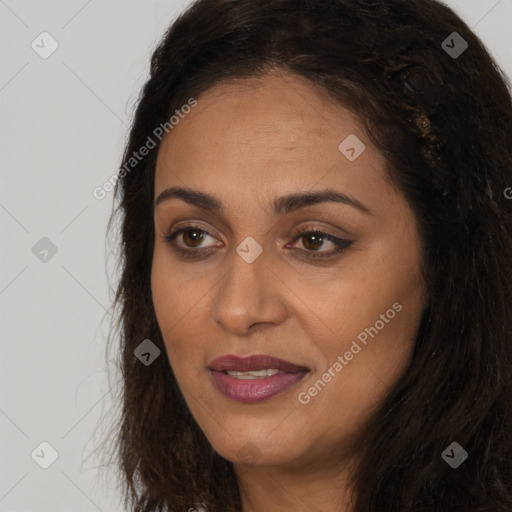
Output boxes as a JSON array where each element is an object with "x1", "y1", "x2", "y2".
[{"x1": 211, "y1": 245, "x2": 288, "y2": 336}]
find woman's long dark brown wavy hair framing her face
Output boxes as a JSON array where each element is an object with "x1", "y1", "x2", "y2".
[{"x1": 102, "y1": 0, "x2": 512, "y2": 512}]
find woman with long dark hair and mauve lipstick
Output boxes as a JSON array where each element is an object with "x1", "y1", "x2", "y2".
[{"x1": 102, "y1": 0, "x2": 512, "y2": 512}]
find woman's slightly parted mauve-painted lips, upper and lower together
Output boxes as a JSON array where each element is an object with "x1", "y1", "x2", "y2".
[{"x1": 208, "y1": 355, "x2": 309, "y2": 403}]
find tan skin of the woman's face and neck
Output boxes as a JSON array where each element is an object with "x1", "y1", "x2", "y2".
[{"x1": 151, "y1": 72, "x2": 426, "y2": 512}]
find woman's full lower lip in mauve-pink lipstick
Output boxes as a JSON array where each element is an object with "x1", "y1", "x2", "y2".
[{"x1": 211, "y1": 370, "x2": 308, "y2": 404}]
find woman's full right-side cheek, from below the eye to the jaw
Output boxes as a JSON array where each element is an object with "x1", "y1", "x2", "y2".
[{"x1": 305, "y1": 242, "x2": 425, "y2": 394}]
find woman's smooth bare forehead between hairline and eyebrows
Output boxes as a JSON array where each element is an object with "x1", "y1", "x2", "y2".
[{"x1": 155, "y1": 70, "x2": 398, "y2": 218}]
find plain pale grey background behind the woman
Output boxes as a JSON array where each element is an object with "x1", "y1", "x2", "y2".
[{"x1": 0, "y1": 0, "x2": 512, "y2": 512}]
